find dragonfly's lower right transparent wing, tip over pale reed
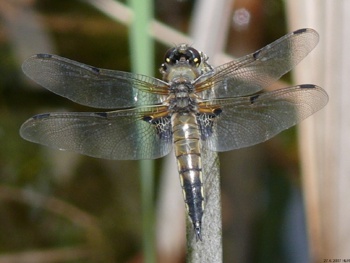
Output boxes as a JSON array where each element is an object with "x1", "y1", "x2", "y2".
[{"x1": 201, "y1": 85, "x2": 328, "y2": 151}]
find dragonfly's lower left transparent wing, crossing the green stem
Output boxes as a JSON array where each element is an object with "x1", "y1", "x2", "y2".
[{"x1": 20, "y1": 108, "x2": 172, "y2": 160}]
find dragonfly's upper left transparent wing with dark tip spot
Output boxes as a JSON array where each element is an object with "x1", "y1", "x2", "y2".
[{"x1": 22, "y1": 54, "x2": 168, "y2": 109}]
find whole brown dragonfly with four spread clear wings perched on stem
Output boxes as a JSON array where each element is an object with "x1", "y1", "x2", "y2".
[{"x1": 20, "y1": 29, "x2": 328, "y2": 240}]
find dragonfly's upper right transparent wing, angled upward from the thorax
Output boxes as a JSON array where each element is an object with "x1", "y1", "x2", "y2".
[{"x1": 196, "y1": 29, "x2": 319, "y2": 99}]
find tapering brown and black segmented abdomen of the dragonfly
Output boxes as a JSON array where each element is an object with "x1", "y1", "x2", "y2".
[{"x1": 172, "y1": 113, "x2": 204, "y2": 239}]
